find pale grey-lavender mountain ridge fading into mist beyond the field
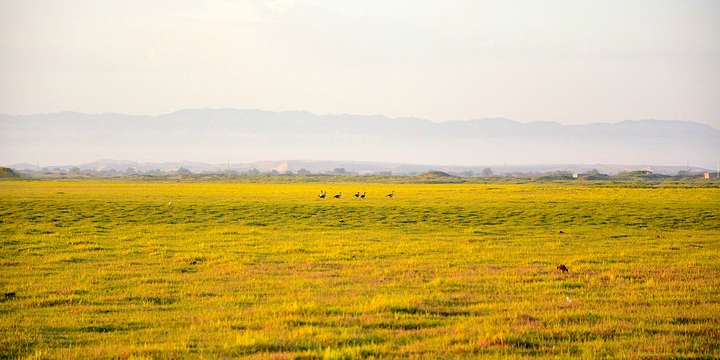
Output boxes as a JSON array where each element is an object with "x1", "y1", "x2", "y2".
[{"x1": 0, "y1": 109, "x2": 720, "y2": 168}]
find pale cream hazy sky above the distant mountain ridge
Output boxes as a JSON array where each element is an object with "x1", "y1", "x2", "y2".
[{"x1": 0, "y1": 0, "x2": 720, "y2": 128}]
